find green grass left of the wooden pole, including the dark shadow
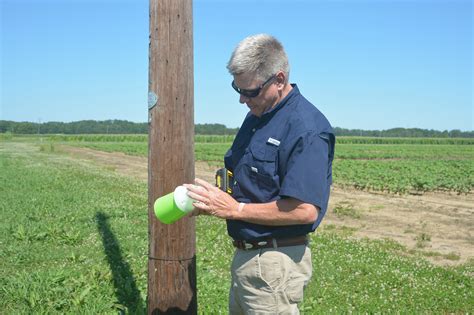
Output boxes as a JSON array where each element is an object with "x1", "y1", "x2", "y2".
[{"x1": 0, "y1": 145, "x2": 147, "y2": 314}]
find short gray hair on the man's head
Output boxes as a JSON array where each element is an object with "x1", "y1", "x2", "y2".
[{"x1": 227, "y1": 34, "x2": 290, "y2": 81}]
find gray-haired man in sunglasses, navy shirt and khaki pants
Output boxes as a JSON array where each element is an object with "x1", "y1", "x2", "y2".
[{"x1": 186, "y1": 34, "x2": 335, "y2": 314}]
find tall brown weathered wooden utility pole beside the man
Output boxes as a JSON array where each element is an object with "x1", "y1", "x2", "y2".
[{"x1": 147, "y1": 0, "x2": 197, "y2": 314}]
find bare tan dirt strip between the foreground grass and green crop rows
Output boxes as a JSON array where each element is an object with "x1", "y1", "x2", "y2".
[{"x1": 61, "y1": 146, "x2": 474, "y2": 265}]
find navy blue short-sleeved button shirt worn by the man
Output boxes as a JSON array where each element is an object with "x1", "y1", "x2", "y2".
[{"x1": 224, "y1": 84, "x2": 335, "y2": 240}]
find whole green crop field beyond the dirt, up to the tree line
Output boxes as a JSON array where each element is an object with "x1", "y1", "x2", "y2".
[{"x1": 27, "y1": 135, "x2": 474, "y2": 194}]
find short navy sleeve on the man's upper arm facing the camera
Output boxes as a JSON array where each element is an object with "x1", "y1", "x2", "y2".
[{"x1": 280, "y1": 131, "x2": 334, "y2": 210}]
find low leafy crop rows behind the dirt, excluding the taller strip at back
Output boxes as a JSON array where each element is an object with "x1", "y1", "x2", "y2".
[{"x1": 61, "y1": 142, "x2": 474, "y2": 194}]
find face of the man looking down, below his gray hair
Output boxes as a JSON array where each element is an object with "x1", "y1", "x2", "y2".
[{"x1": 234, "y1": 73, "x2": 279, "y2": 117}]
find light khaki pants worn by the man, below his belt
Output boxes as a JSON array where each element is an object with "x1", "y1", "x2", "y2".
[{"x1": 229, "y1": 245, "x2": 312, "y2": 315}]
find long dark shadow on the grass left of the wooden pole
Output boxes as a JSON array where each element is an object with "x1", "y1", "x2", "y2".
[{"x1": 95, "y1": 212, "x2": 145, "y2": 314}]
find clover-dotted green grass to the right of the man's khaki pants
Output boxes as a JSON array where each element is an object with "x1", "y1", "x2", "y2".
[{"x1": 303, "y1": 234, "x2": 474, "y2": 314}]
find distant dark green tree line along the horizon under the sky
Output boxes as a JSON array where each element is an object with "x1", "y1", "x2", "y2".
[{"x1": 0, "y1": 119, "x2": 474, "y2": 138}]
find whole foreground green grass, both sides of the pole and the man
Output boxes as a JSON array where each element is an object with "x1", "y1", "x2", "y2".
[{"x1": 0, "y1": 139, "x2": 474, "y2": 314}]
